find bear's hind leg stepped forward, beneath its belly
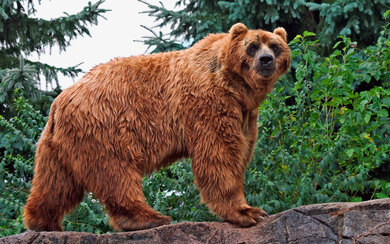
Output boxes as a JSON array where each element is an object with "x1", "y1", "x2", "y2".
[{"x1": 92, "y1": 159, "x2": 171, "y2": 231}]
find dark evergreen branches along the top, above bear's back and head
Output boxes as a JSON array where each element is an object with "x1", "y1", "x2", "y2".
[{"x1": 139, "y1": 0, "x2": 390, "y2": 52}]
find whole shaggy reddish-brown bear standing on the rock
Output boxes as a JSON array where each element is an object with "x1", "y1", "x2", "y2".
[{"x1": 24, "y1": 23, "x2": 290, "y2": 231}]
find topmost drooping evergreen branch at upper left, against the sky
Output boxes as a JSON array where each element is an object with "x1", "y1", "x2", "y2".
[{"x1": 0, "y1": 0, "x2": 110, "y2": 56}]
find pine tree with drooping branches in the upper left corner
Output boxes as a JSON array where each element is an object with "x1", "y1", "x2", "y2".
[{"x1": 0, "y1": 0, "x2": 108, "y2": 117}]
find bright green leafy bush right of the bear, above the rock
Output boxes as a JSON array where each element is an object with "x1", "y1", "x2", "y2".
[{"x1": 246, "y1": 29, "x2": 390, "y2": 213}]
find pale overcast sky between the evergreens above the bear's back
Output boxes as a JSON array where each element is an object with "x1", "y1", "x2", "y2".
[{"x1": 31, "y1": 0, "x2": 176, "y2": 89}]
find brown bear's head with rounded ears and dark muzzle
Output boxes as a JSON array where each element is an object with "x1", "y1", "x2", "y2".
[{"x1": 225, "y1": 23, "x2": 290, "y2": 89}]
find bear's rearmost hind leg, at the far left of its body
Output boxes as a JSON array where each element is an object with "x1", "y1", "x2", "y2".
[{"x1": 24, "y1": 143, "x2": 84, "y2": 231}]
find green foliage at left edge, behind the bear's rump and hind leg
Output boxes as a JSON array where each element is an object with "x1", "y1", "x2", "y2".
[{"x1": 0, "y1": 92, "x2": 46, "y2": 236}]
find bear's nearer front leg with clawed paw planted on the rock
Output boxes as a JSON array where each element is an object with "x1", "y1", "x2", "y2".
[{"x1": 192, "y1": 112, "x2": 268, "y2": 227}]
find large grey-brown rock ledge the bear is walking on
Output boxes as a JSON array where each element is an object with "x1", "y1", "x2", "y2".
[{"x1": 0, "y1": 199, "x2": 390, "y2": 244}]
